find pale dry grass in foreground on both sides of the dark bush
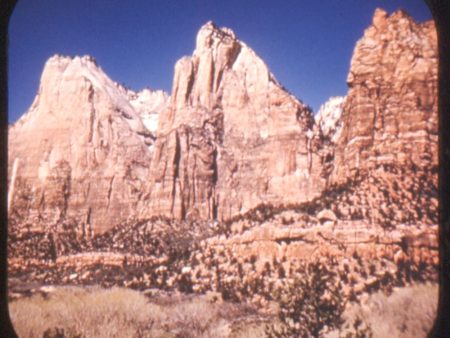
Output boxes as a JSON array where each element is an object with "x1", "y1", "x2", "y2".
[{"x1": 9, "y1": 284, "x2": 438, "y2": 338}]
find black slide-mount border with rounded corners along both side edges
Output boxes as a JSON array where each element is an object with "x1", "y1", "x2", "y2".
[{"x1": 0, "y1": 0, "x2": 450, "y2": 338}]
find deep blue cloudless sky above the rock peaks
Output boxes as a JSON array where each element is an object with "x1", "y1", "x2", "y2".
[{"x1": 9, "y1": 0, "x2": 431, "y2": 122}]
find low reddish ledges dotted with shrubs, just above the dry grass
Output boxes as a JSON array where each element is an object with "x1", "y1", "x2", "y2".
[{"x1": 9, "y1": 209, "x2": 438, "y2": 307}]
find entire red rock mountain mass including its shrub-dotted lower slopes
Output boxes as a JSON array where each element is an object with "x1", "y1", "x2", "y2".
[{"x1": 8, "y1": 10, "x2": 438, "y2": 322}]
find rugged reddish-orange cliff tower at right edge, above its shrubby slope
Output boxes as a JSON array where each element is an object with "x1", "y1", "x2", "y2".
[{"x1": 331, "y1": 9, "x2": 438, "y2": 183}]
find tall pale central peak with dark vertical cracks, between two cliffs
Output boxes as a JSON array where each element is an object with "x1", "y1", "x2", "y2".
[{"x1": 142, "y1": 22, "x2": 325, "y2": 219}]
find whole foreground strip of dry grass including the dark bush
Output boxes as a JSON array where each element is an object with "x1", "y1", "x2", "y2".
[{"x1": 9, "y1": 282, "x2": 437, "y2": 338}]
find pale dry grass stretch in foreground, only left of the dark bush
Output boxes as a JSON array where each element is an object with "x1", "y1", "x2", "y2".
[{"x1": 9, "y1": 288, "x2": 265, "y2": 338}]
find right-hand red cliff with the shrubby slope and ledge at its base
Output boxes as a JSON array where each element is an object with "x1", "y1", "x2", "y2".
[{"x1": 201, "y1": 10, "x2": 438, "y2": 274}]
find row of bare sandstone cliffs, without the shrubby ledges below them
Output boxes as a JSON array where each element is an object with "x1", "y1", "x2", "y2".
[{"x1": 8, "y1": 10, "x2": 437, "y2": 236}]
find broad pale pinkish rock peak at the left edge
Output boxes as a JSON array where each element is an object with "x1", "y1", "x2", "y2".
[{"x1": 9, "y1": 56, "x2": 153, "y2": 233}]
